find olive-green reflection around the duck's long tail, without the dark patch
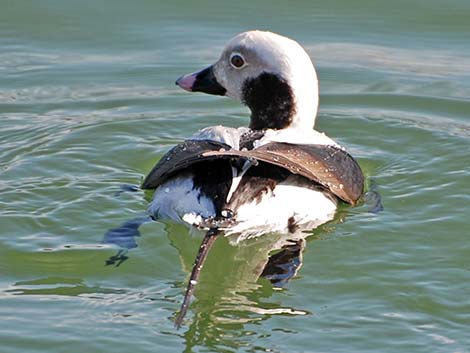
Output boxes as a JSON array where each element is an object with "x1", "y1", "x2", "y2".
[{"x1": 167, "y1": 225, "x2": 307, "y2": 352}]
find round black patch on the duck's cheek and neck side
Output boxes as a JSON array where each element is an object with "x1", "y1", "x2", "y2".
[{"x1": 242, "y1": 72, "x2": 295, "y2": 130}]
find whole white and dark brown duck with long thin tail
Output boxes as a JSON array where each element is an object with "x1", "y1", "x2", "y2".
[{"x1": 142, "y1": 30, "x2": 364, "y2": 325}]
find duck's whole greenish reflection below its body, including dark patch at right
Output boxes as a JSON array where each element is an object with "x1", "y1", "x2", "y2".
[{"x1": 166, "y1": 205, "x2": 374, "y2": 352}]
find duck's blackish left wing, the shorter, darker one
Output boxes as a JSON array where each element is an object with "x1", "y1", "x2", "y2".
[{"x1": 142, "y1": 140, "x2": 232, "y2": 189}]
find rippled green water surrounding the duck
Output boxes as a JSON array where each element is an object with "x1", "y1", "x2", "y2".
[{"x1": 0, "y1": 0, "x2": 470, "y2": 353}]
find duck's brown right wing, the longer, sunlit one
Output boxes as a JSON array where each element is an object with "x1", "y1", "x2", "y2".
[{"x1": 203, "y1": 142, "x2": 364, "y2": 205}]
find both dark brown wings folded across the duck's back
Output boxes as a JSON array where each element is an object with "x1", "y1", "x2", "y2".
[{"x1": 142, "y1": 140, "x2": 364, "y2": 205}]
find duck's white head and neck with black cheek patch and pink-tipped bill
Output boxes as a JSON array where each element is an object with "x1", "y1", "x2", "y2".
[{"x1": 176, "y1": 31, "x2": 318, "y2": 130}]
